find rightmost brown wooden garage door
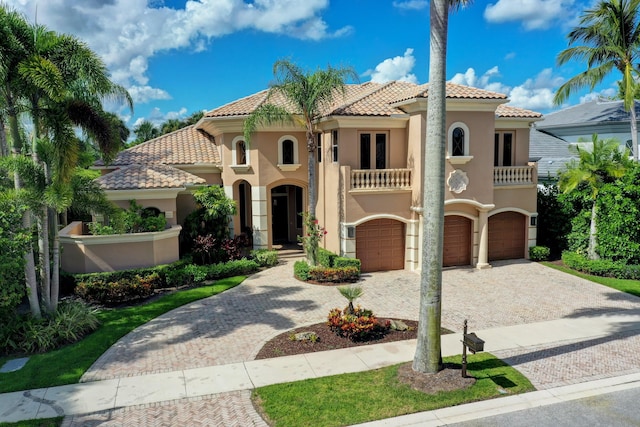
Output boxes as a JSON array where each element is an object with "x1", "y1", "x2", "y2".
[{"x1": 489, "y1": 212, "x2": 526, "y2": 261}]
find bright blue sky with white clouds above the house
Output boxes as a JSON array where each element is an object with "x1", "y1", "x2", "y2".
[{"x1": 5, "y1": 0, "x2": 619, "y2": 127}]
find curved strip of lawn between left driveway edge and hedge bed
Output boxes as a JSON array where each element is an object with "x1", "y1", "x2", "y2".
[{"x1": 0, "y1": 276, "x2": 245, "y2": 393}]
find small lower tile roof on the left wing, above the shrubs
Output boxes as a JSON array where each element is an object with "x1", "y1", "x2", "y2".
[{"x1": 97, "y1": 164, "x2": 206, "y2": 190}]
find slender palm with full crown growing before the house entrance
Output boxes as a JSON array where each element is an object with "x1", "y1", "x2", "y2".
[{"x1": 244, "y1": 60, "x2": 357, "y2": 264}]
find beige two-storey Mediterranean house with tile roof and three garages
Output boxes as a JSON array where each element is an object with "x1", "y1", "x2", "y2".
[{"x1": 87, "y1": 81, "x2": 542, "y2": 271}]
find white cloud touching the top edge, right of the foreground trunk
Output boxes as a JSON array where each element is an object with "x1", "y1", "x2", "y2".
[{"x1": 484, "y1": 0, "x2": 578, "y2": 30}]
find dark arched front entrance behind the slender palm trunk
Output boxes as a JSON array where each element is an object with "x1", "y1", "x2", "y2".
[{"x1": 271, "y1": 185, "x2": 304, "y2": 245}]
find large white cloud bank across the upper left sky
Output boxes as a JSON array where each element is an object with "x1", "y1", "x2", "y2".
[{"x1": 12, "y1": 0, "x2": 344, "y2": 100}]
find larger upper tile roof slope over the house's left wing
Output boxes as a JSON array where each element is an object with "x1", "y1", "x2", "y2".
[{"x1": 96, "y1": 125, "x2": 220, "y2": 166}]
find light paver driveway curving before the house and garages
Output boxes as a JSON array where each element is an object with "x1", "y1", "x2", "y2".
[{"x1": 83, "y1": 261, "x2": 640, "y2": 381}]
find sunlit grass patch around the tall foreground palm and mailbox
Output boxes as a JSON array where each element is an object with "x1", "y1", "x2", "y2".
[{"x1": 253, "y1": 353, "x2": 535, "y2": 427}]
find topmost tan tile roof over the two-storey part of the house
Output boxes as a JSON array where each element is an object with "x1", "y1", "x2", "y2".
[{"x1": 204, "y1": 81, "x2": 542, "y2": 118}]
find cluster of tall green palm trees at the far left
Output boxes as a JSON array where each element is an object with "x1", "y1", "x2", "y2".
[{"x1": 0, "y1": 7, "x2": 132, "y2": 316}]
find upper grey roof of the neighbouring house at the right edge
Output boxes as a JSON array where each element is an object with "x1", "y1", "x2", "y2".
[{"x1": 536, "y1": 100, "x2": 640, "y2": 135}]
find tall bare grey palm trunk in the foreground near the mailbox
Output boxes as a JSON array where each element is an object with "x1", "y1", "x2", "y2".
[{"x1": 413, "y1": 0, "x2": 470, "y2": 373}]
